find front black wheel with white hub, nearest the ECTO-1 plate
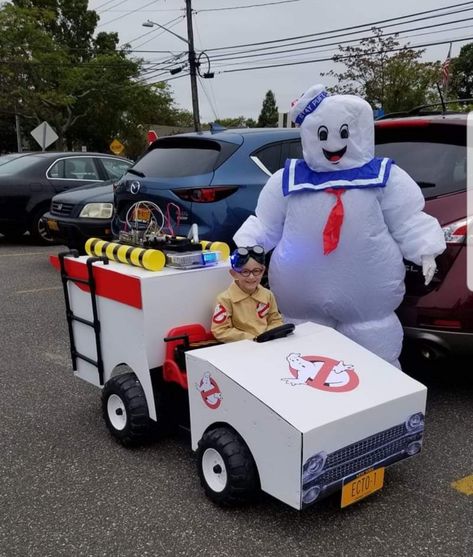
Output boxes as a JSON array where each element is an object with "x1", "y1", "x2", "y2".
[{"x1": 197, "y1": 427, "x2": 260, "y2": 506}]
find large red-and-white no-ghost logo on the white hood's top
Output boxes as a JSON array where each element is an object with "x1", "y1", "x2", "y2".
[{"x1": 281, "y1": 352, "x2": 360, "y2": 392}]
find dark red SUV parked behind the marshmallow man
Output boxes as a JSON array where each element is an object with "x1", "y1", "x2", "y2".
[{"x1": 375, "y1": 113, "x2": 473, "y2": 359}]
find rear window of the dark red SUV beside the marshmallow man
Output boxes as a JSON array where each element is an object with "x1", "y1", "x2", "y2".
[{"x1": 376, "y1": 121, "x2": 466, "y2": 199}]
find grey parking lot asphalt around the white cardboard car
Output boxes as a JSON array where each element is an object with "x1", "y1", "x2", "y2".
[{"x1": 0, "y1": 235, "x2": 473, "y2": 557}]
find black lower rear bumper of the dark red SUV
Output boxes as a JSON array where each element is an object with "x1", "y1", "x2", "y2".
[{"x1": 404, "y1": 327, "x2": 473, "y2": 356}]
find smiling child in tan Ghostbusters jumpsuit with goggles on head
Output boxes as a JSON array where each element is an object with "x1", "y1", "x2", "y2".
[{"x1": 211, "y1": 246, "x2": 283, "y2": 342}]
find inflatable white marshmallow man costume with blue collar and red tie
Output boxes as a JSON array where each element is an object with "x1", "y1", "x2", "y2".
[{"x1": 234, "y1": 85, "x2": 445, "y2": 366}]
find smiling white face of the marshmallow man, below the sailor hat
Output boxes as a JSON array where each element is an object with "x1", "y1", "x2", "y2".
[{"x1": 301, "y1": 95, "x2": 374, "y2": 172}]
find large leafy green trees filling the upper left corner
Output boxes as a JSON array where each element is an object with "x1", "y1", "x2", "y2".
[{"x1": 0, "y1": 0, "x2": 182, "y2": 151}]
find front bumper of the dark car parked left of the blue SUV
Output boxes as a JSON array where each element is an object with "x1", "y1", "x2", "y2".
[{"x1": 44, "y1": 213, "x2": 112, "y2": 247}]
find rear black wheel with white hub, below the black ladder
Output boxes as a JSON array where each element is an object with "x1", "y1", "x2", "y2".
[{"x1": 102, "y1": 373, "x2": 154, "y2": 446}]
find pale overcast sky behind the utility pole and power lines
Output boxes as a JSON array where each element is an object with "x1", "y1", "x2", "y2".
[{"x1": 89, "y1": 0, "x2": 473, "y2": 122}]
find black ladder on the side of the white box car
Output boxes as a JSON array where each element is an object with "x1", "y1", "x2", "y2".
[{"x1": 58, "y1": 250, "x2": 108, "y2": 385}]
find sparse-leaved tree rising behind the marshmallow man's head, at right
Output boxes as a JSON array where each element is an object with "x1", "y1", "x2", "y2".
[{"x1": 322, "y1": 27, "x2": 440, "y2": 112}]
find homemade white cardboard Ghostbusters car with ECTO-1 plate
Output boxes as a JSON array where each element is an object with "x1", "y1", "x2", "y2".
[{"x1": 51, "y1": 252, "x2": 427, "y2": 509}]
